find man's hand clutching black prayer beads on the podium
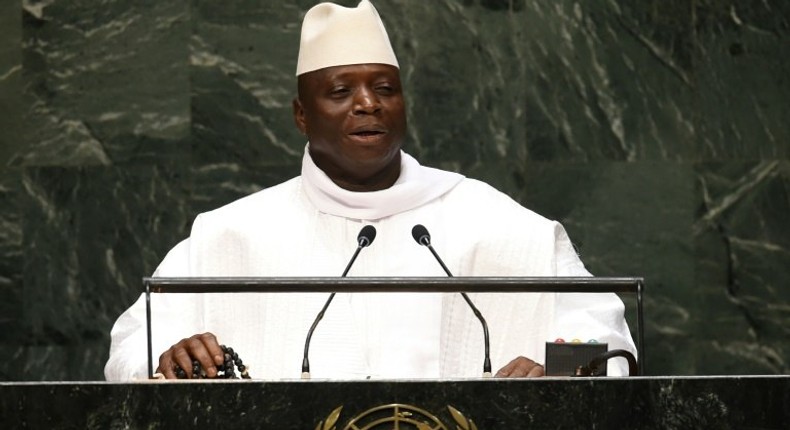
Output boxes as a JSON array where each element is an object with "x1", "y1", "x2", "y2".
[{"x1": 156, "y1": 333, "x2": 224, "y2": 379}]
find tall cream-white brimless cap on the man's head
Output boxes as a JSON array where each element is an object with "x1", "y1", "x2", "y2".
[{"x1": 296, "y1": 0, "x2": 398, "y2": 76}]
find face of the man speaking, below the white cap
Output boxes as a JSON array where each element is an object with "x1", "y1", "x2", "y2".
[{"x1": 294, "y1": 64, "x2": 406, "y2": 191}]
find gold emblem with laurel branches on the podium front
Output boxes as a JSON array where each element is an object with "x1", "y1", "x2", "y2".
[{"x1": 315, "y1": 403, "x2": 477, "y2": 430}]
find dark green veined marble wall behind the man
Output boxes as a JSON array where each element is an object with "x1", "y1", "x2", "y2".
[{"x1": 0, "y1": 0, "x2": 790, "y2": 380}]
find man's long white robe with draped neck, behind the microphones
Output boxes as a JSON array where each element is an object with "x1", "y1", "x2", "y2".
[{"x1": 105, "y1": 147, "x2": 636, "y2": 381}]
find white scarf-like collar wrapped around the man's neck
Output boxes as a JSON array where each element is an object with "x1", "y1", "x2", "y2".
[{"x1": 302, "y1": 147, "x2": 464, "y2": 220}]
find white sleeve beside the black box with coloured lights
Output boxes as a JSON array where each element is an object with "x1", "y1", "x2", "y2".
[{"x1": 552, "y1": 227, "x2": 636, "y2": 376}]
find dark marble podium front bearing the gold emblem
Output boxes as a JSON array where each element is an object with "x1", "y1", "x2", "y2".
[{"x1": 0, "y1": 376, "x2": 790, "y2": 430}]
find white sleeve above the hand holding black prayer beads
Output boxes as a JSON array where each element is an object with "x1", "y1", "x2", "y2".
[{"x1": 104, "y1": 239, "x2": 201, "y2": 381}]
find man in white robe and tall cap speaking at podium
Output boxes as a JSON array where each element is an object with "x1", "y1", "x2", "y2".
[{"x1": 105, "y1": 0, "x2": 635, "y2": 380}]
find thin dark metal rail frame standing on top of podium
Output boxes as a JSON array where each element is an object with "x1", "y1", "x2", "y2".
[{"x1": 143, "y1": 277, "x2": 645, "y2": 378}]
